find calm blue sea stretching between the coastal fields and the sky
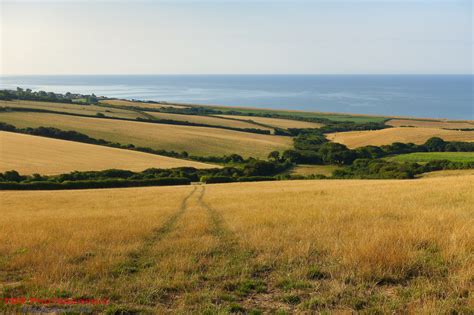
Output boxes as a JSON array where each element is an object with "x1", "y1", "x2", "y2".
[{"x1": 0, "y1": 75, "x2": 474, "y2": 119}]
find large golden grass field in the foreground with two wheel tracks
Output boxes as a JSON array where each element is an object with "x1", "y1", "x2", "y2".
[{"x1": 0, "y1": 176, "x2": 474, "y2": 314}]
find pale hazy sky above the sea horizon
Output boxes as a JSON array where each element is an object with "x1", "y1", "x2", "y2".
[{"x1": 0, "y1": 0, "x2": 474, "y2": 74}]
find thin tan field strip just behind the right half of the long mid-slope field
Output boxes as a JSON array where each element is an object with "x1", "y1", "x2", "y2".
[{"x1": 146, "y1": 112, "x2": 273, "y2": 131}]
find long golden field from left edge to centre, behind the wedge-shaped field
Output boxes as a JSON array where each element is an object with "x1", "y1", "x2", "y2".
[{"x1": 0, "y1": 112, "x2": 292, "y2": 157}]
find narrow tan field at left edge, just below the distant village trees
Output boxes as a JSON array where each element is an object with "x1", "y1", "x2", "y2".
[{"x1": 0, "y1": 100, "x2": 143, "y2": 119}]
